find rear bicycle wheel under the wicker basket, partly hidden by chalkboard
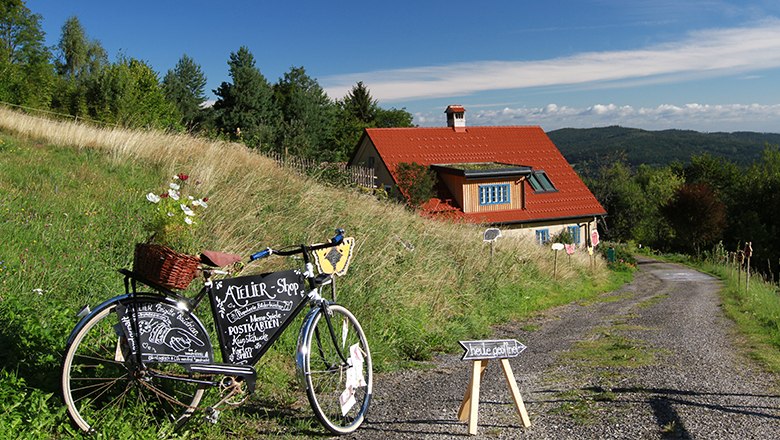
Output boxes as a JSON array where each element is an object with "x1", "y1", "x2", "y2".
[{"x1": 62, "y1": 299, "x2": 206, "y2": 438}]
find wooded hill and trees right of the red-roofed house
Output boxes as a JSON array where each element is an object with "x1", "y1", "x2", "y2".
[{"x1": 548, "y1": 126, "x2": 780, "y2": 279}]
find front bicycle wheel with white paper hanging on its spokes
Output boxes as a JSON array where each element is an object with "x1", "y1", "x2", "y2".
[{"x1": 302, "y1": 304, "x2": 373, "y2": 434}]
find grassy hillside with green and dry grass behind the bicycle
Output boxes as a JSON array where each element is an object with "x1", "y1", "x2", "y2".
[{"x1": 0, "y1": 105, "x2": 614, "y2": 438}]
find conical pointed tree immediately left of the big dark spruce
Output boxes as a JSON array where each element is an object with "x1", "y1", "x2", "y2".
[{"x1": 162, "y1": 54, "x2": 206, "y2": 131}]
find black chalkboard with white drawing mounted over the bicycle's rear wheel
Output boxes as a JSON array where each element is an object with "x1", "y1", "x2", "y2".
[{"x1": 116, "y1": 301, "x2": 214, "y2": 364}]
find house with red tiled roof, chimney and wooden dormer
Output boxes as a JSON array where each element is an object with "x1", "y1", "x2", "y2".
[{"x1": 350, "y1": 105, "x2": 606, "y2": 245}]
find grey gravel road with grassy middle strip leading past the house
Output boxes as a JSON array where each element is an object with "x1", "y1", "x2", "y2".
[{"x1": 349, "y1": 259, "x2": 780, "y2": 440}]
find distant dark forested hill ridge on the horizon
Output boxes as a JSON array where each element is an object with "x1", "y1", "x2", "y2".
[{"x1": 547, "y1": 126, "x2": 780, "y2": 171}]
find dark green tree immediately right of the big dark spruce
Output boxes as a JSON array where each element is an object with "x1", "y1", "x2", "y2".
[{"x1": 273, "y1": 67, "x2": 339, "y2": 160}]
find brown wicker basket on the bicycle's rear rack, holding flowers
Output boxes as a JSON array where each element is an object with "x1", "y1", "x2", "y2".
[{"x1": 133, "y1": 243, "x2": 200, "y2": 289}]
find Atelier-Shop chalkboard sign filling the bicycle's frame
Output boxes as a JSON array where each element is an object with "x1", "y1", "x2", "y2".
[{"x1": 211, "y1": 270, "x2": 306, "y2": 365}]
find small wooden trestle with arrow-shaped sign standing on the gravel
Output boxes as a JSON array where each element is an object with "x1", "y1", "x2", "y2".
[{"x1": 458, "y1": 339, "x2": 531, "y2": 435}]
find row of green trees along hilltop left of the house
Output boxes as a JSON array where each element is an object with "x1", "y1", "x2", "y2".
[{"x1": 0, "y1": 0, "x2": 412, "y2": 161}]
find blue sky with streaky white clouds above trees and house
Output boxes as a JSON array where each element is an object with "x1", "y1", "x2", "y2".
[{"x1": 27, "y1": 0, "x2": 780, "y2": 132}]
